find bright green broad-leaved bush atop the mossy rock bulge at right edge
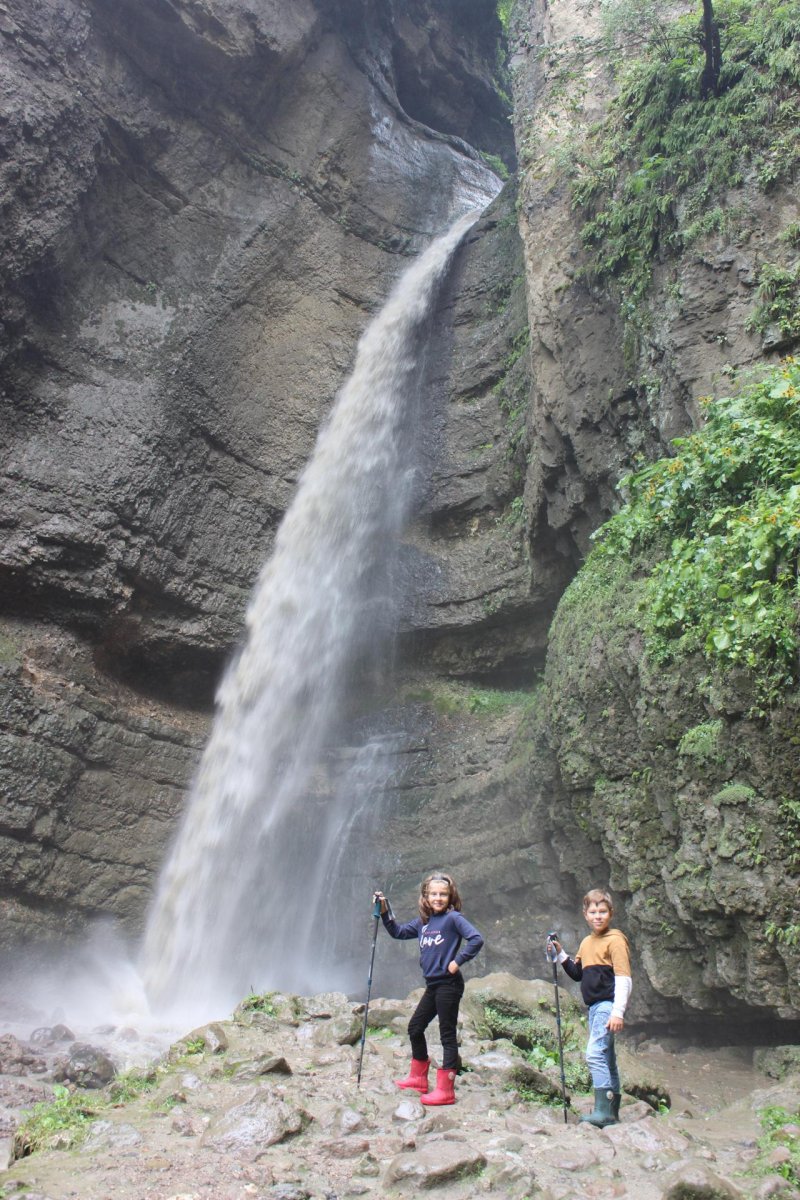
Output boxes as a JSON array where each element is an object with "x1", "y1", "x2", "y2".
[{"x1": 592, "y1": 359, "x2": 800, "y2": 710}]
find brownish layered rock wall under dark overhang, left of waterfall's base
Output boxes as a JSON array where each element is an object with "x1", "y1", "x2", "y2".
[{"x1": 0, "y1": 618, "x2": 206, "y2": 945}]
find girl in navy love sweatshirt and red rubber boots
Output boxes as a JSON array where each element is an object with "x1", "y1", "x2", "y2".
[{"x1": 373, "y1": 871, "x2": 483, "y2": 1104}]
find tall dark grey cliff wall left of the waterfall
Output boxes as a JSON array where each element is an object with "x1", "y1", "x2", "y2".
[{"x1": 0, "y1": 0, "x2": 513, "y2": 934}]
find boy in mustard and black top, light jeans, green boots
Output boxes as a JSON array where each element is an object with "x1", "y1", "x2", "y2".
[{"x1": 553, "y1": 888, "x2": 633, "y2": 1129}]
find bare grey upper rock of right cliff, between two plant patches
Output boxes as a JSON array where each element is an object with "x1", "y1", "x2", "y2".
[{"x1": 511, "y1": 0, "x2": 799, "y2": 566}]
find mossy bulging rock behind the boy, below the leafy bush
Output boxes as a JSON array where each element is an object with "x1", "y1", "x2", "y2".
[{"x1": 546, "y1": 564, "x2": 800, "y2": 1031}]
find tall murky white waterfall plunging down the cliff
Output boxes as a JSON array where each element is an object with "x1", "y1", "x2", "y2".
[{"x1": 143, "y1": 214, "x2": 477, "y2": 1019}]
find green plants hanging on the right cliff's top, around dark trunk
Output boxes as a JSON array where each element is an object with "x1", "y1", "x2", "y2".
[{"x1": 572, "y1": 0, "x2": 800, "y2": 317}]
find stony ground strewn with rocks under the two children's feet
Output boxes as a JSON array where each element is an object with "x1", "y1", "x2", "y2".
[{"x1": 0, "y1": 974, "x2": 800, "y2": 1200}]
